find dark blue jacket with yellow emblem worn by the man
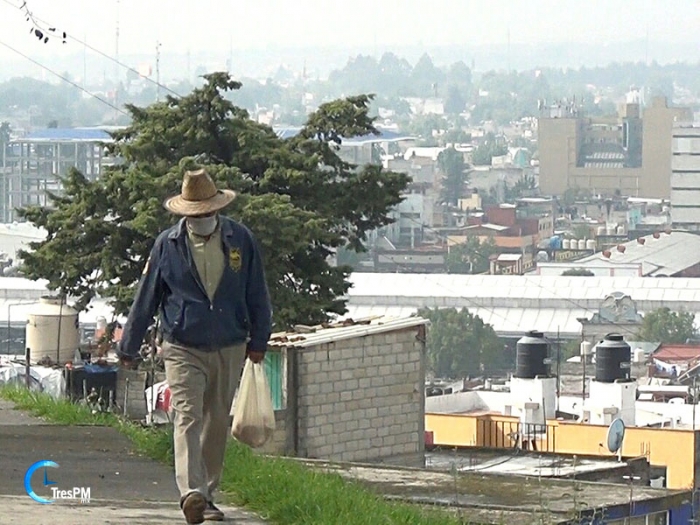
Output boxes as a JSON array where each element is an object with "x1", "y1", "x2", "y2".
[{"x1": 117, "y1": 217, "x2": 272, "y2": 357}]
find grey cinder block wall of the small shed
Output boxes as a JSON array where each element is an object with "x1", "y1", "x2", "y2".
[{"x1": 290, "y1": 327, "x2": 425, "y2": 463}]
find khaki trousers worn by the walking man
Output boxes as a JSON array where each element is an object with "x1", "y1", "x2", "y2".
[{"x1": 163, "y1": 342, "x2": 245, "y2": 501}]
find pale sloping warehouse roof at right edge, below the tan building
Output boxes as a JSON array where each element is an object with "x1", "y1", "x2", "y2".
[{"x1": 576, "y1": 232, "x2": 700, "y2": 277}]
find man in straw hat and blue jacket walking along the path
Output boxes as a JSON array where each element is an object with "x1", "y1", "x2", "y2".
[{"x1": 118, "y1": 170, "x2": 272, "y2": 524}]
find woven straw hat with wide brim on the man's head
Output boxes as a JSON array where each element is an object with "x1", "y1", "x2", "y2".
[{"x1": 163, "y1": 169, "x2": 236, "y2": 217}]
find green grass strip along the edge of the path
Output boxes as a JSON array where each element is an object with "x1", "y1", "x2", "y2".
[{"x1": 0, "y1": 386, "x2": 467, "y2": 525}]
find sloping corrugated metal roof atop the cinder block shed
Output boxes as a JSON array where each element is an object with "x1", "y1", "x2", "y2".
[{"x1": 268, "y1": 316, "x2": 429, "y2": 348}]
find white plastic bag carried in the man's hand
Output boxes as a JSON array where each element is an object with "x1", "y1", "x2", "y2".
[{"x1": 231, "y1": 359, "x2": 275, "y2": 448}]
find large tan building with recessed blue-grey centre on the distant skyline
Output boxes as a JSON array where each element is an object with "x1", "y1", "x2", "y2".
[{"x1": 538, "y1": 97, "x2": 692, "y2": 198}]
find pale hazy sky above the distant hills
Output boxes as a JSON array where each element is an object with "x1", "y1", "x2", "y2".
[{"x1": 0, "y1": 0, "x2": 700, "y2": 59}]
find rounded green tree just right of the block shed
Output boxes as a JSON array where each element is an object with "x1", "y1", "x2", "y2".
[{"x1": 418, "y1": 308, "x2": 507, "y2": 378}]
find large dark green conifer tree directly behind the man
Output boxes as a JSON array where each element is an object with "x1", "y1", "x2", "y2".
[{"x1": 21, "y1": 73, "x2": 408, "y2": 328}]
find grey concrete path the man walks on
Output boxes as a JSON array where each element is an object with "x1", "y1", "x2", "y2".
[{"x1": 0, "y1": 400, "x2": 265, "y2": 525}]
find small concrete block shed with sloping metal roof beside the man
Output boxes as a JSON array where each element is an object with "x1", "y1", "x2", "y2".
[{"x1": 264, "y1": 317, "x2": 428, "y2": 466}]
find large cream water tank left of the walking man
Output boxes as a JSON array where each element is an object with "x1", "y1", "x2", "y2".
[{"x1": 27, "y1": 297, "x2": 80, "y2": 364}]
